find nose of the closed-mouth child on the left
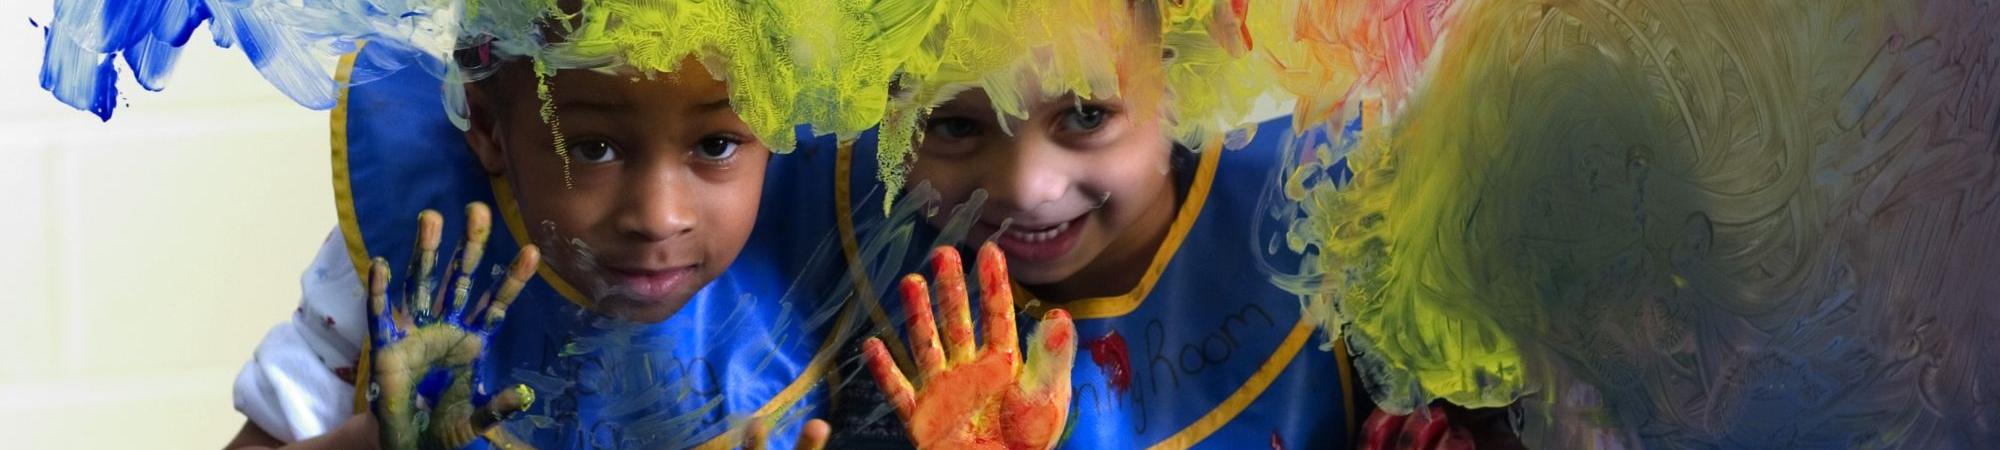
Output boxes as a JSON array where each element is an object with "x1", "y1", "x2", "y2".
[{"x1": 616, "y1": 172, "x2": 700, "y2": 242}]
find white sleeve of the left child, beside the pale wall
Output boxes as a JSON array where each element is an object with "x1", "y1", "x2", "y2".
[{"x1": 236, "y1": 228, "x2": 368, "y2": 442}]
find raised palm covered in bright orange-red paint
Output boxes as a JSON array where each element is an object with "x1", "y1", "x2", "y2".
[{"x1": 862, "y1": 242, "x2": 1076, "y2": 450}]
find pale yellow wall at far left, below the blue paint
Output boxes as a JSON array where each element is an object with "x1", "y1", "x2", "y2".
[{"x1": 0, "y1": 20, "x2": 334, "y2": 448}]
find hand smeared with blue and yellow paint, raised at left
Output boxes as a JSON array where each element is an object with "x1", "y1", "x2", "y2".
[{"x1": 368, "y1": 202, "x2": 540, "y2": 450}]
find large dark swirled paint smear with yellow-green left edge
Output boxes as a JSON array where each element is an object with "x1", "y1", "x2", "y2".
[{"x1": 1274, "y1": 0, "x2": 2000, "y2": 448}]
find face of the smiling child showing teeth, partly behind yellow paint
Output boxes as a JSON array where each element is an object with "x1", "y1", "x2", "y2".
[{"x1": 910, "y1": 90, "x2": 1174, "y2": 284}]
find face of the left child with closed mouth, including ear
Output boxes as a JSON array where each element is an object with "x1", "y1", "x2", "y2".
[{"x1": 466, "y1": 62, "x2": 770, "y2": 322}]
